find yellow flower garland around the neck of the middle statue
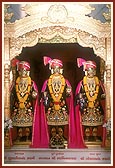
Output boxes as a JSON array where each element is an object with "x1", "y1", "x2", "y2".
[{"x1": 48, "y1": 74, "x2": 65, "y2": 110}]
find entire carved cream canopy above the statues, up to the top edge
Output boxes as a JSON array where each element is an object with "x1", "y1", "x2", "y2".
[{"x1": 4, "y1": 2, "x2": 111, "y2": 59}]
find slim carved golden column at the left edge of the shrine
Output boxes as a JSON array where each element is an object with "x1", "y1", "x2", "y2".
[{"x1": 3, "y1": 38, "x2": 11, "y2": 147}]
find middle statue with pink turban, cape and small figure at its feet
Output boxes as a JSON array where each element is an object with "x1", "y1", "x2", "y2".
[{"x1": 41, "y1": 57, "x2": 76, "y2": 148}]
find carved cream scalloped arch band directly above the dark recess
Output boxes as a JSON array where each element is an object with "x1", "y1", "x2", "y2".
[{"x1": 10, "y1": 26, "x2": 106, "y2": 60}]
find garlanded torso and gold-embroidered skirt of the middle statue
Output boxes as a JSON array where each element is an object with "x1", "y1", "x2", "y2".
[{"x1": 47, "y1": 71, "x2": 68, "y2": 125}]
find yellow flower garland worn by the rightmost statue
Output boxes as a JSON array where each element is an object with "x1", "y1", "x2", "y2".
[{"x1": 83, "y1": 76, "x2": 99, "y2": 108}]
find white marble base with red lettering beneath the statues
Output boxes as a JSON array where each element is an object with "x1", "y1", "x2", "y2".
[{"x1": 3, "y1": 145, "x2": 112, "y2": 166}]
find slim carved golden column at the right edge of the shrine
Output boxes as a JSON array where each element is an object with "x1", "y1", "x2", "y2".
[{"x1": 105, "y1": 38, "x2": 112, "y2": 148}]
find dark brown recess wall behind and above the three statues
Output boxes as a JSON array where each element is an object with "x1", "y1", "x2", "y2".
[{"x1": 17, "y1": 43, "x2": 100, "y2": 93}]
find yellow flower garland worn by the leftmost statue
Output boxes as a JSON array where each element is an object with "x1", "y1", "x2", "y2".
[{"x1": 16, "y1": 77, "x2": 31, "y2": 108}]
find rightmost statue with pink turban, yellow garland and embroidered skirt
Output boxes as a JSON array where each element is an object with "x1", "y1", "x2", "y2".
[{"x1": 75, "y1": 58, "x2": 105, "y2": 145}]
